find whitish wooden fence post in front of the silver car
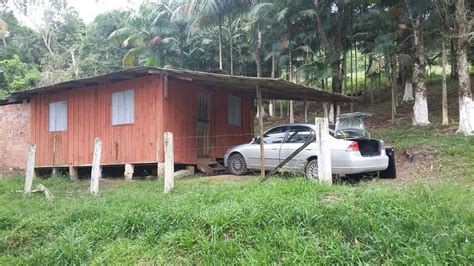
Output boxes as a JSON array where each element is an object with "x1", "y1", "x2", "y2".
[{"x1": 315, "y1": 117, "x2": 332, "y2": 184}]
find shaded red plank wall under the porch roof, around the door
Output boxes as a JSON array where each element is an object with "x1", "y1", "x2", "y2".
[{"x1": 161, "y1": 79, "x2": 254, "y2": 164}]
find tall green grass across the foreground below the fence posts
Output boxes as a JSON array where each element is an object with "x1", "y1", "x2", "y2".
[{"x1": 0, "y1": 178, "x2": 474, "y2": 265}]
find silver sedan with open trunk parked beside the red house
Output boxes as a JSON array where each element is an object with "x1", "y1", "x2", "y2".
[{"x1": 224, "y1": 124, "x2": 388, "y2": 179}]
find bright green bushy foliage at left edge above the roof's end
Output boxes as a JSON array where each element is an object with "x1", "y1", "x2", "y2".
[{"x1": 0, "y1": 55, "x2": 40, "y2": 96}]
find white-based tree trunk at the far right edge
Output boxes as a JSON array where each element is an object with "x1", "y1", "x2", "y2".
[{"x1": 456, "y1": 0, "x2": 474, "y2": 135}]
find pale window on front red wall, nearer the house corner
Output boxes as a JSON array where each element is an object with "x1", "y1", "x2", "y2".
[{"x1": 112, "y1": 90, "x2": 134, "y2": 125}]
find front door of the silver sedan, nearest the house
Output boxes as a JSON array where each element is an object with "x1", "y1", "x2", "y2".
[{"x1": 247, "y1": 126, "x2": 288, "y2": 170}]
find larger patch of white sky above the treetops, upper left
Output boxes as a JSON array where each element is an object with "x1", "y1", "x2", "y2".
[{"x1": 68, "y1": 0, "x2": 144, "y2": 23}]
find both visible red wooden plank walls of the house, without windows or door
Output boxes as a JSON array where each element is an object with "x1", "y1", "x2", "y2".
[{"x1": 31, "y1": 76, "x2": 254, "y2": 167}]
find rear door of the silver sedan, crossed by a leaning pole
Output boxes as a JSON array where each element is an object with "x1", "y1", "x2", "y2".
[{"x1": 280, "y1": 126, "x2": 318, "y2": 172}]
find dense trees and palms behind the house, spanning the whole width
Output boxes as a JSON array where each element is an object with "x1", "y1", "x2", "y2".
[{"x1": 0, "y1": 0, "x2": 474, "y2": 134}]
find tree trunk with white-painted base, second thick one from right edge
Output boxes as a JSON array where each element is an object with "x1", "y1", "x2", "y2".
[{"x1": 413, "y1": 16, "x2": 430, "y2": 126}]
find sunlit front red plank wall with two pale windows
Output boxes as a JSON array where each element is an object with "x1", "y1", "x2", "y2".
[{"x1": 31, "y1": 76, "x2": 160, "y2": 167}]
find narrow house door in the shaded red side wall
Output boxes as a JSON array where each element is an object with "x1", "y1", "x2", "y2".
[{"x1": 196, "y1": 94, "x2": 211, "y2": 158}]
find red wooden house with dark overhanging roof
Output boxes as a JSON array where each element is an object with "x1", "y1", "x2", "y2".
[{"x1": 3, "y1": 67, "x2": 350, "y2": 177}]
